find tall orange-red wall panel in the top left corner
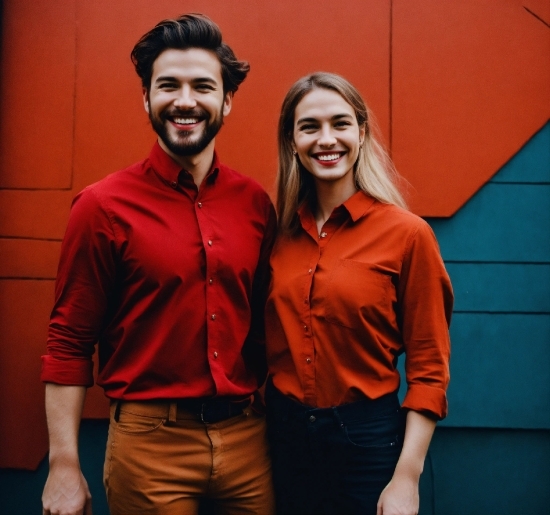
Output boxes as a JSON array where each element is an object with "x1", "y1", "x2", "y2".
[{"x1": 0, "y1": 0, "x2": 76, "y2": 189}]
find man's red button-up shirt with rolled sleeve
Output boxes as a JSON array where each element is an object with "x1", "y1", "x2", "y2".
[{"x1": 42, "y1": 144, "x2": 276, "y2": 400}]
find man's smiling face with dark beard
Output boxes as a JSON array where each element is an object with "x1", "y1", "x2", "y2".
[{"x1": 143, "y1": 48, "x2": 232, "y2": 158}]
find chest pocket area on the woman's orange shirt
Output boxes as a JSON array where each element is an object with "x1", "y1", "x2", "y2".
[{"x1": 321, "y1": 259, "x2": 395, "y2": 329}]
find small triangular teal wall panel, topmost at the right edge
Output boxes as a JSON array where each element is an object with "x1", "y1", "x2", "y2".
[{"x1": 491, "y1": 123, "x2": 550, "y2": 183}]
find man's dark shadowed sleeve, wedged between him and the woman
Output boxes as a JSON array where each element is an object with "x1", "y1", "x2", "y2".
[{"x1": 243, "y1": 199, "x2": 277, "y2": 385}]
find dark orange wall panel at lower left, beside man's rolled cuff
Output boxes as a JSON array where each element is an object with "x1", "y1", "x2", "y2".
[{"x1": 0, "y1": 279, "x2": 54, "y2": 469}]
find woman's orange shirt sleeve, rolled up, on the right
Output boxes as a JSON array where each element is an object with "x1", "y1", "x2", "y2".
[{"x1": 398, "y1": 221, "x2": 453, "y2": 419}]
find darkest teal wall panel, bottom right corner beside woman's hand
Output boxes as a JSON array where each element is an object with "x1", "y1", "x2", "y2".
[{"x1": 432, "y1": 428, "x2": 550, "y2": 515}]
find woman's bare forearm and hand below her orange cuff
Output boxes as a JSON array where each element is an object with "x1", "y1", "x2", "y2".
[{"x1": 376, "y1": 411, "x2": 436, "y2": 515}]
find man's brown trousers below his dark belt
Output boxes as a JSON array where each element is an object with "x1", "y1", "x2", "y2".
[{"x1": 104, "y1": 402, "x2": 275, "y2": 515}]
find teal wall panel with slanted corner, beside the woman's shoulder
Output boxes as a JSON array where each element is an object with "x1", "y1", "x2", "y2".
[{"x1": 428, "y1": 183, "x2": 550, "y2": 263}]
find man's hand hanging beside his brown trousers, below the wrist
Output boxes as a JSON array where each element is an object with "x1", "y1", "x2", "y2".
[{"x1": 42, "y1": 465, "x2": 92, "y2": 515}]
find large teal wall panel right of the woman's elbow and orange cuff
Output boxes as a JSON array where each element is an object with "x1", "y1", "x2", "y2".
[{"x1": 441, "y1": 313, "x2": 550, "y2": 429}]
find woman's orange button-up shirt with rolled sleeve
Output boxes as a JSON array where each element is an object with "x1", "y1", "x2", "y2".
[{"x1": 266, "y1": 192, "x2": 453, "y2": 418}]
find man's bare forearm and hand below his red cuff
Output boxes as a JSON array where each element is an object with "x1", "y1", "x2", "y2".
[{"x1": 42, "y1": 383, "x2": 92, "y2": 515}]
